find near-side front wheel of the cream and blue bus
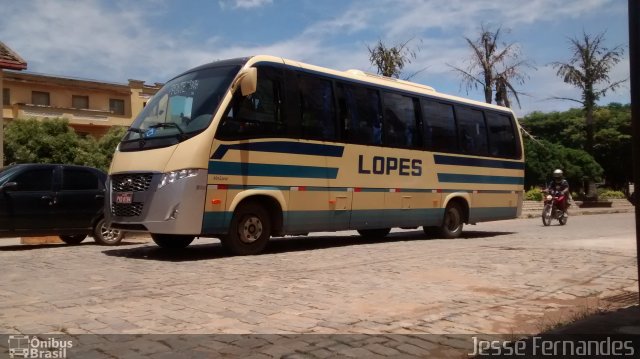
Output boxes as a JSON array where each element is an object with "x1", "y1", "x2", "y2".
[{"x1": 221, "y1": 202, "x2": 271, "y2": 256}]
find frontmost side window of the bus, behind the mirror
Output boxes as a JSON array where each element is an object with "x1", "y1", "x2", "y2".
[{"x1": 218, "y1": 67, "x2": 287, "y2": 140}]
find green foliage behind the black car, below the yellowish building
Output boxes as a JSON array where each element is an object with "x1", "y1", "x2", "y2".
[{"x1": 4, "y1": 118, "x2": 126, "y2": 170}]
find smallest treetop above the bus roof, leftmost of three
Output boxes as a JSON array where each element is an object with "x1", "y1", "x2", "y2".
[{"x1": 367, "y1": 38, "x2": 422, "y2": 80}]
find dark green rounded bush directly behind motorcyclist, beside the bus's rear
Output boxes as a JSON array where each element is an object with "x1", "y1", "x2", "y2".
[{"x1": 524, "y1": 138, "x2": 603, "y2": 188}]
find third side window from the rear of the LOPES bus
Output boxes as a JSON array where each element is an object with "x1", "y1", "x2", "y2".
[{"x1": 420, "y1": 98, "x2": 458, "y2": 152}]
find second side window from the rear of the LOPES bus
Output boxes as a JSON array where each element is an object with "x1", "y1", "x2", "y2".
[{"x1": 455, "y1": 106, "x2": 489, "y2": 155}]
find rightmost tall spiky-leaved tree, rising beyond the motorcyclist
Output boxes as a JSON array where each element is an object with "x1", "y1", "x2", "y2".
[{"x1": 552, "y1": 32, "x2": 626, "y2": 154}]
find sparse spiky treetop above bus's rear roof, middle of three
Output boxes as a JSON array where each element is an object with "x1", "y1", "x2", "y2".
[{"x1": 449, "y1": 24, "x2": 534, "y2": 107}]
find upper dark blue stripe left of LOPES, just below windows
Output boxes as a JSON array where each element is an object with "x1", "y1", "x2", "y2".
[{"x1": 211, "y1": 141, "x2": 344, "y2": 160}]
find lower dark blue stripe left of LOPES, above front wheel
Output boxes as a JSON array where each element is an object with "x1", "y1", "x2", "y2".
[{"x1": 209, "y1": 161, "x2": 338, "y2": 179}]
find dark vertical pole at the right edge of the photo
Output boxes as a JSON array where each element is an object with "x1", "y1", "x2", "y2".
[{"x1": 629, "y1": 0, "x2": 640, "y2": 300}]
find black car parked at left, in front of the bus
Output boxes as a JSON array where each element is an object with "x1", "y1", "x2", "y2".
[{"x1": 0, "y1": 164, "x2": 124, "y2": 245}]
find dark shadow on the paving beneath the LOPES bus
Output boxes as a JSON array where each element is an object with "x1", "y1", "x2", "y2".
[{"x1": 103, "y1": 230, "x2": 513, "y2": 262}]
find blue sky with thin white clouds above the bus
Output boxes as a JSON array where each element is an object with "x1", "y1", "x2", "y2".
[{"x1": 0, "y1": 0, "x2": 630, "y2": 116}]
